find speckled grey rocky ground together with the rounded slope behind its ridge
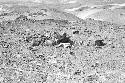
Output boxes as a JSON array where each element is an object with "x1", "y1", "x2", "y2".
[{"x1": 0, "y1": 2, "x2": 125, "y2": 83}]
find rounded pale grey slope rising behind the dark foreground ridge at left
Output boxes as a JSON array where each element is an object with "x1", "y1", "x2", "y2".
[{"x1": 0, "y1": 3, "x2": 82, "y2": 21}]
